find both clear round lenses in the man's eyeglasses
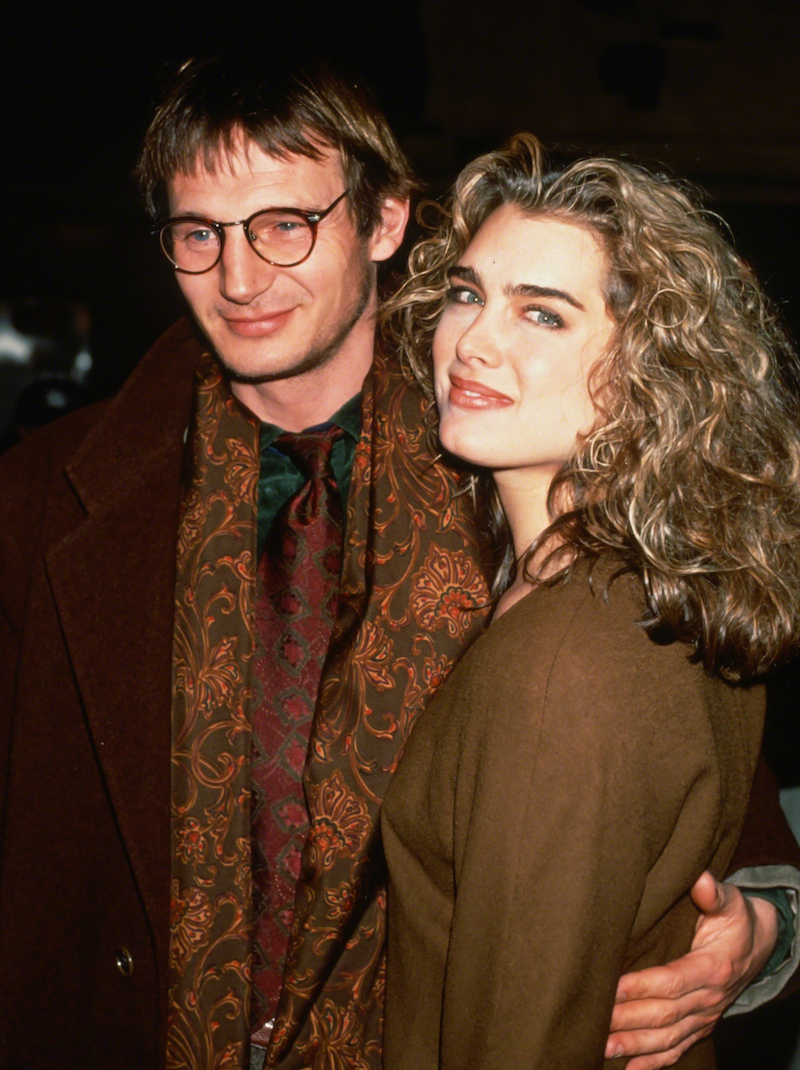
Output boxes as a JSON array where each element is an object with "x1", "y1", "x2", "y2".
[{"x1": 161, "y1": 209, "x2": 314, "y2": 272}]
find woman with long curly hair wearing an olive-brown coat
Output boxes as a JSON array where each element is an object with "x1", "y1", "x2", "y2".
[{"x1": 383, "y1": 135, "x2": 800, "y2": 1070}]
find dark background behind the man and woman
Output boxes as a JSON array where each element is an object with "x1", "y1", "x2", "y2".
[{"x1": 0, "y1": 0, "x2": 800, "y2": 1070}]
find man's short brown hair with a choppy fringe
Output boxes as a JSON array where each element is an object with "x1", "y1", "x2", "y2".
[{"x1": 136, "y1": 51, "x2": 417, "y2": 235}]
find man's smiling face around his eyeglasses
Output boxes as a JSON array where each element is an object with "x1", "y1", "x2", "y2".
[{"x1": 169, "y1": 142, "x2": 382, "y2": 382}]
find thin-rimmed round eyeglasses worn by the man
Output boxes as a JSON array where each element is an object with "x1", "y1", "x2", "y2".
[{"x1": 153, "y1": 189, "x2": 350, "y2": 275}]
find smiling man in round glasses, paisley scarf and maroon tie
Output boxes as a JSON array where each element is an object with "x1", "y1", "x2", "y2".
[{"x1": 0, "y1": 48, "x2": 795, "y2": 1070}]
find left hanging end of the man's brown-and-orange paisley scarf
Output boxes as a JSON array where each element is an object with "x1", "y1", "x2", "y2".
[{"x1": 167, "y1": 354, "x2": 259, "y2": 1070}]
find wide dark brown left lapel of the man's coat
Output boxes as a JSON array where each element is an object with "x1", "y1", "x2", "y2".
[{"x1": 46, "y1": 316, "x2": 200, "y2": 961}]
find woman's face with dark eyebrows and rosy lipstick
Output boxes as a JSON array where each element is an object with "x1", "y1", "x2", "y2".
[{"x1": 433, "y1": 204, "x2": 614, "y2": 482}]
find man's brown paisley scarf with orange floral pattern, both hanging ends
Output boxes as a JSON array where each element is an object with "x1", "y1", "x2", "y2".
[{"x1": 167, "y1": 346, "x2": 488, "y2": 1070}]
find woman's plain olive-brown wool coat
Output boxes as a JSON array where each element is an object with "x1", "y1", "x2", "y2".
[{"x1": 382, "y1": 569, "x2": 764, "y2": 1070}]
